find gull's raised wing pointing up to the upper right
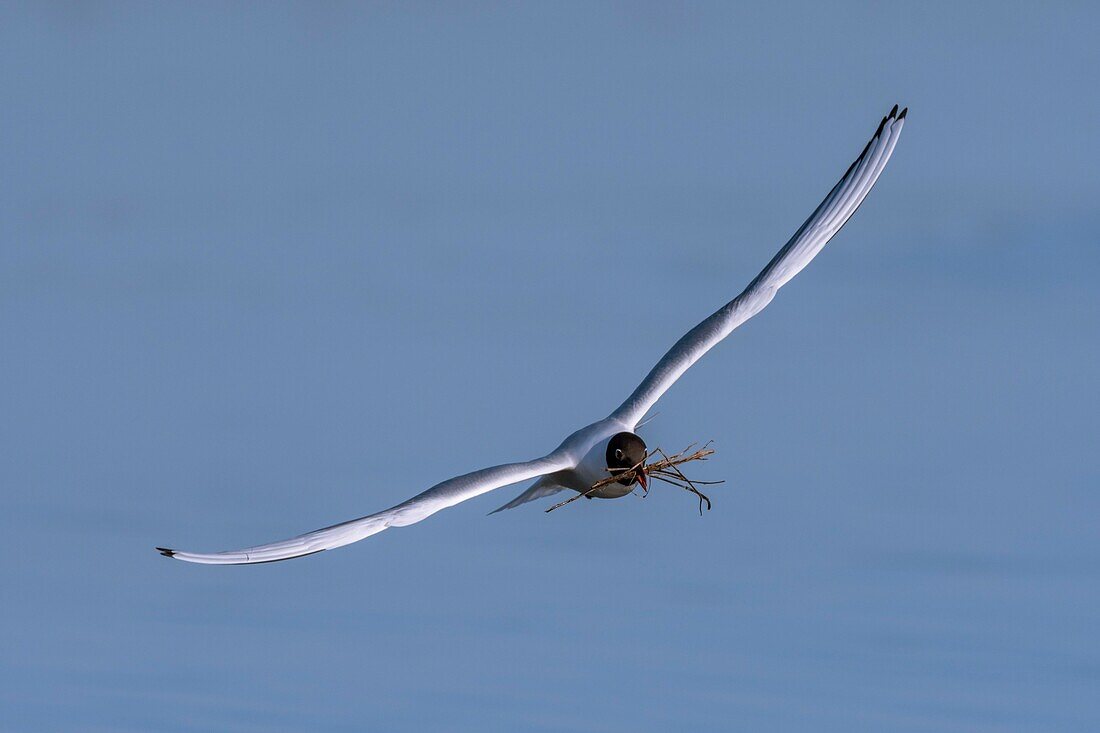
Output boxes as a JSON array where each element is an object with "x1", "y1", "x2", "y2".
[{"x1": 611, "y1": 105, "x2": 909, "y2": 425}]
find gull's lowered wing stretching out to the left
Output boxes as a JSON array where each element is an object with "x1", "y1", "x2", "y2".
[{"x1": 156, "y1": 450, "x2": 574, "y2": 565}]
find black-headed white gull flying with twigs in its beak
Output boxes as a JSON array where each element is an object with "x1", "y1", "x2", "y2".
[{"x1": 156, "y1": 105, "x2": 909, "y2": 565}]
